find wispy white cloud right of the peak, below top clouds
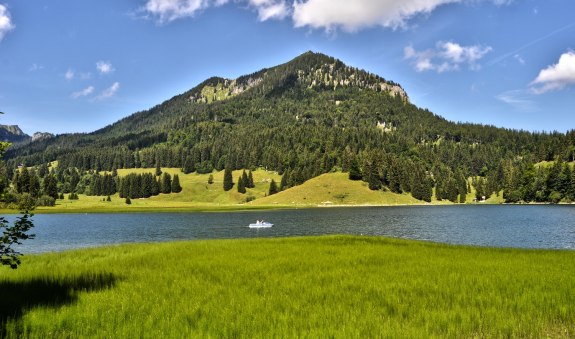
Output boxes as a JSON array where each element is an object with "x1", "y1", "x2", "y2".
[{"x1": 403, "y1": 41, "x2": 492, "y2": 73}]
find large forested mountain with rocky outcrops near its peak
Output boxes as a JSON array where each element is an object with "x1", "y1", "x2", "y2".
[{"x1": 6, "y1": 52, "x2": 575, "y2": 205}]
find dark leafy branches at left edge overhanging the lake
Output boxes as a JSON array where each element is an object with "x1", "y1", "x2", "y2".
[{"x1": 0, "y1": 211, "x2": 34, "y2": 270}]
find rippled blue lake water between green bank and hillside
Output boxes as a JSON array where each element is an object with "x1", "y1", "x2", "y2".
[{"x1": 9, "y1": 205, "x2": 575, "y2": 253}]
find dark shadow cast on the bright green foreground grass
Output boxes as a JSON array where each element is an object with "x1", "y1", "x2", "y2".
[{"x1": 0, "y1": 273, "x2": 117, "y2": 338}]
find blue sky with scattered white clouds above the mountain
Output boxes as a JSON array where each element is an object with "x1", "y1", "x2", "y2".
[{"x1": 0, "y1": 0, "x2": 575, "y2": 134}]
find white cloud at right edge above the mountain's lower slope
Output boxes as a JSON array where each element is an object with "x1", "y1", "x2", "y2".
[{"x1": 530, "y1": 51, "x2": 575, "y2": 94}]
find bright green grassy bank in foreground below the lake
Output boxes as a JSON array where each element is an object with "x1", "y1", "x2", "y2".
[{"x1": 0, "y1": 236, "x2": 575, "y2": 338}]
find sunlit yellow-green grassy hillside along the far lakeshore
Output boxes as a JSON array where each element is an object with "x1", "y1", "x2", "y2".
[{"x1": 13, "y1": 168, "x2": 502, "y2": 213}]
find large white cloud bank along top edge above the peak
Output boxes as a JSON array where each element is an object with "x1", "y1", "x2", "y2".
[{"x1": 141, "y1": 0, "x2": 513, "y2": 31}]
